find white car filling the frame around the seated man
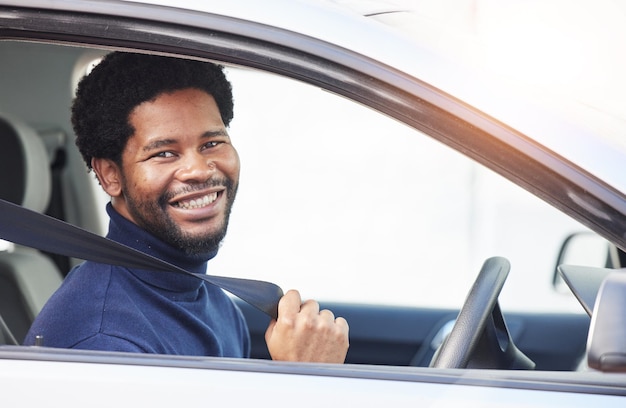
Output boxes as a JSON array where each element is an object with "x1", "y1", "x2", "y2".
[{"x1": 0, "y1": 0, "x2": 626, "y2": 407}]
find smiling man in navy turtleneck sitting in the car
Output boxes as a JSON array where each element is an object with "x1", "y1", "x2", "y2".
[{"x1": 25, "y1": 53, "x2": 348, "y2": 363}]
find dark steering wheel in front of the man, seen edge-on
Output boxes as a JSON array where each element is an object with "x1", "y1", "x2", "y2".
[{"x1": 430, "y1": 257, "x2": 535, "y2": 369}]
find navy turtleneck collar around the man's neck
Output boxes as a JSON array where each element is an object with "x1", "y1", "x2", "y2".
[{"x1": 106, "y1": 203, "x2": 217, "y2": 289}]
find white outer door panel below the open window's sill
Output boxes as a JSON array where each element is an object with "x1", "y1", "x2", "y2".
[{"x1": 0, "y1": 348, "x2": 625, "y2": 407}]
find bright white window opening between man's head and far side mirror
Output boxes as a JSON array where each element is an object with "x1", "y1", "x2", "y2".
[{"x1": 188, "y1": 67, "x2": 586, "y2": 312}]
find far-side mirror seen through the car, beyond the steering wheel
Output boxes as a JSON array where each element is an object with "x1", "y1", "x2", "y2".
[{"x1": 552, "y1": 232, "x2": 621, "y2": 293}]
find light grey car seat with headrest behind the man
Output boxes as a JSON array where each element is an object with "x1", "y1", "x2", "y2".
[{"x1": 0, "y1": 113, "x2": 63, "y2": 342}]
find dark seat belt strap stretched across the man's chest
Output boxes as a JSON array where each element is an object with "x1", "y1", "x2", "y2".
[{"x1": 0, "y1": 199, "x2": 283, "y2": 319}]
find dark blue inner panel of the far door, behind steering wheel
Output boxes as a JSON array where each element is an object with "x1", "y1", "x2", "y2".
[{"x1": 237, "y1": 300, "x2": 589, "y2": 370}]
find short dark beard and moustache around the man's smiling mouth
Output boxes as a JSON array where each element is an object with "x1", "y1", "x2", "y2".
[{"x1": 122, "y1": 178, "x2": 237, "y2": 255}]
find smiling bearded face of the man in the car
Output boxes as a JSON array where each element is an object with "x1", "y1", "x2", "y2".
[{"x1": 98, "y1": 89, "x2": 239, "y2": 254}]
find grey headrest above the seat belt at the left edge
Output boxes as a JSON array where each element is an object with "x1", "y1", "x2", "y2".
[{"x1": 0, "y1": 113, "x2": 51, "y2": 213}]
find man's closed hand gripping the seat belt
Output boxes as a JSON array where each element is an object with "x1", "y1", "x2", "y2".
[{"x1": 265, "y1": 290, "x2": 349, "y2": 363}]
